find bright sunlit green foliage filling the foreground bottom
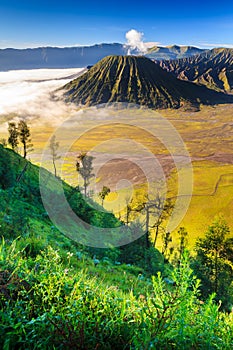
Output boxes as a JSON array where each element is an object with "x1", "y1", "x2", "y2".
[{"x1": 0, "y1": 241, "x2": 233, "y2": 350}]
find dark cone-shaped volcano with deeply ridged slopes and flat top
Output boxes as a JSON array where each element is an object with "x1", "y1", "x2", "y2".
[{"x1": 61, "y1": 56, "x2": 233, "y2": 108}]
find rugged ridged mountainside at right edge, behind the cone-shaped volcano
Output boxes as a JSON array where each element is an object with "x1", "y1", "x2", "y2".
[{"x1": 160, "y1": 48, "x2": 233, "y2": 92}]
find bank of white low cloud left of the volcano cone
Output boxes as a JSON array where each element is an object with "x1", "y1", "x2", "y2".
[{"x1": 0, "y1": 68, "x2": 86, "y2": 129}]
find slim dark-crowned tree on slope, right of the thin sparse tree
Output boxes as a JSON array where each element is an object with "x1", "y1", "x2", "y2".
[{"x1": 76, "y1": 152, "x2": 94, "y2": 196}]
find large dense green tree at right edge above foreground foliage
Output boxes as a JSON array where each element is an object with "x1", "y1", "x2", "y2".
[{"x1": 193, "y1": 219, "x2": 233, "y2": 307}]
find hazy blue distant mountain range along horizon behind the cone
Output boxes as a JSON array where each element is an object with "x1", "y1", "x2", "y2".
[{"x1": 0, "y1": 43, "x2": 206, "y2": 71}]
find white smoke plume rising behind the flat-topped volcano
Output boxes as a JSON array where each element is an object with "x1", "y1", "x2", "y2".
[{"x1": 125, "y1": 29, "x2": 148, "y2": 55}]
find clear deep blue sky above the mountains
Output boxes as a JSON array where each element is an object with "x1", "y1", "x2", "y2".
[{"x1": 0, "y1": 0, "x2": 233, "y2": 48}]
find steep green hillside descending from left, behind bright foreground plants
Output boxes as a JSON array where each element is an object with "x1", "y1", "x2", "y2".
[{"x1": 0, "y1": 145, "x2": 163, "y2": 271}]
